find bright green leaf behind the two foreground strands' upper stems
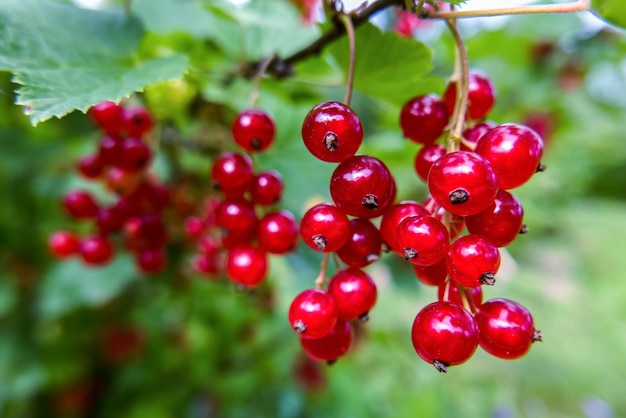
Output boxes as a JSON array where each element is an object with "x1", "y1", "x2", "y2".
[{"x1": 328, "y1": 23, "x2": 443, "y2": 106}]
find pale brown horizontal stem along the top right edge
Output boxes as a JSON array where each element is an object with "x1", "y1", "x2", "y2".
[{"x1": 421, "y1": 0, "x2": 590, "y2": 19}]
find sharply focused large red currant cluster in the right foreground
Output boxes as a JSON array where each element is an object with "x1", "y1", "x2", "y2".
[{"x1": 289, "y1": 72, "x2": 544, "y2": 372}]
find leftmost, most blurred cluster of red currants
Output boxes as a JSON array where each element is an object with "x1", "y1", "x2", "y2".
[{"x1": 48, "y1": 102, "x2": 170, "y2": 274}]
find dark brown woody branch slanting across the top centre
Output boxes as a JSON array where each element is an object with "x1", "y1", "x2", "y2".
[{"x1": 239, "y1": 0, "x2": 404, "y2": 79}]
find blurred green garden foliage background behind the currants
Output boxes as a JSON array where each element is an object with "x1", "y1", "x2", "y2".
[{"x1": 0, "y1": 0, "x2": 626, "y2": 418}]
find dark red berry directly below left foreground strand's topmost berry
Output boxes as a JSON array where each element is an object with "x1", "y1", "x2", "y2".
[{"x1": 330, "y1": 155, "x2": 394, "y2": 218}]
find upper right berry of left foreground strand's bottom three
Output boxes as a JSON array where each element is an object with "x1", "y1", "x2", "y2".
[{"x1": 327, "y1": 267, "x2": 378, "y2": 321}]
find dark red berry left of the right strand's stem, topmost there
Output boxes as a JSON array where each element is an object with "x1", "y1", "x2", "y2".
[{"x1": 400, "y1": 94, "x2": 448, "y2": 144}]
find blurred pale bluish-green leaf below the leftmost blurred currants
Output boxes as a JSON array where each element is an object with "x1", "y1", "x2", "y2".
[{"x1": 39, "y1": 255, "x2": 137, "y2": 319}]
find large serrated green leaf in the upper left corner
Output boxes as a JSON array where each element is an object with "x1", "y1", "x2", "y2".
[{"x1": 0, "y1": 0, "x2": 188, "y2": 124}]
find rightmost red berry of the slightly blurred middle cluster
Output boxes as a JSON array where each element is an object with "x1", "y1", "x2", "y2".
[{"x1": 257, "y1": 210, "x2": 298, "y2": 254}]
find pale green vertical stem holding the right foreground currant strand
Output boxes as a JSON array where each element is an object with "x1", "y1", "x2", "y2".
[{"x1": 446, "y1": 19, "x2": 469, "y2": 152}]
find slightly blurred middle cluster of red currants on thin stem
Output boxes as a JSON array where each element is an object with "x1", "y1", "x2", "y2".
[{"x1": 185, "y1": 109, "x2": 298, "y2": 288}]
